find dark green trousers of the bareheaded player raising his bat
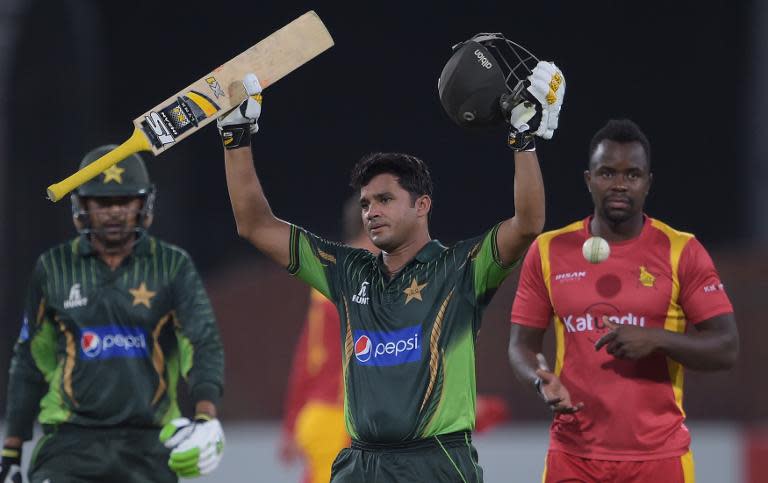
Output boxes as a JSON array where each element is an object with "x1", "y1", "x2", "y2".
[{"x1": 331, "y1": 432, "x2": 483, "y2": 483}]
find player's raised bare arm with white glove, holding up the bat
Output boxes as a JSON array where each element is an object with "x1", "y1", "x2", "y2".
[{"x1": 218, "y1": 74, "x2": 291, "y2": 267}]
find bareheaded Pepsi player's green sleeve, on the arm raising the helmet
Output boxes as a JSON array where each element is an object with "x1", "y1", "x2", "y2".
[{"x1": 470, "y1": 225, "x2": 517, "y2": 306}]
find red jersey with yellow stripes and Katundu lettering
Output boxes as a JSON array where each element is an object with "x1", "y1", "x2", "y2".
[{"x1": 512, "y1": 217, "x2": 733, "y2": 461}]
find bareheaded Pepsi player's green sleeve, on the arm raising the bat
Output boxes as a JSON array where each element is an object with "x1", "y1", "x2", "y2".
[{"x1": 288, "y1": 225, "x2": 360, "y2": 303}]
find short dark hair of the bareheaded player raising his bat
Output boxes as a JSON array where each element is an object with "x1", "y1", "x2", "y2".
[{"x1": 349, "y1": 153, "x2": 432, "y2": 201}]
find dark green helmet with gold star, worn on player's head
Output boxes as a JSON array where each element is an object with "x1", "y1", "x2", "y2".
[{"x1": 71, "y1": 144, "x2": 155, "y2": 233}]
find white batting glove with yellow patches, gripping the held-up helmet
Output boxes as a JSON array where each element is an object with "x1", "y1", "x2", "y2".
[{"x1": 524, "y1": 61, "x2": 565, "y2": 139}]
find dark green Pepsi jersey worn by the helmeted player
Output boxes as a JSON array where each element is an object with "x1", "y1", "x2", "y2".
[{"x1": 6, "y1": 236, "x2": 224, "y2": 439}]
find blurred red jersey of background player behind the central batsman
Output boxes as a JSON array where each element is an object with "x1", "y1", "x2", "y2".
[{"x1": 283, "y1": 289, "x2": 344, "y2": 434}]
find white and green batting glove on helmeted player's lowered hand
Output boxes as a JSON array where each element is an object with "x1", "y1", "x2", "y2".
[{"x1": 160, "y1": 416, "x2": 224, "y2": 478}]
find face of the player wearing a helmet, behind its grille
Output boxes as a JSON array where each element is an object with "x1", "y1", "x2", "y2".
[{"x1": 85, "y1": 196, "x2": 143, "y2": 247}]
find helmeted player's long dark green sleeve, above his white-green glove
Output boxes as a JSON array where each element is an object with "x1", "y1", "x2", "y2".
[{"x1": 173, "y1": 253, "x2": 224, "y2": 404}]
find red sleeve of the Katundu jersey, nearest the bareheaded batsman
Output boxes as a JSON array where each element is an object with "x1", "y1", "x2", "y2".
[{"x1": 511, "y1": 240, "x2": 553, "y2": 329}]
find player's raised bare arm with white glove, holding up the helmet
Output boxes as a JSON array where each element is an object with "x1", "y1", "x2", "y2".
[{"x1": 496, "y1": 61, "x2": 565, "y2": 265}]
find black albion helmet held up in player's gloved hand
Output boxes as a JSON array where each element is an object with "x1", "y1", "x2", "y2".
[{"x1": 437, "y1": 33, "x2": 539, "y2": 127}]
